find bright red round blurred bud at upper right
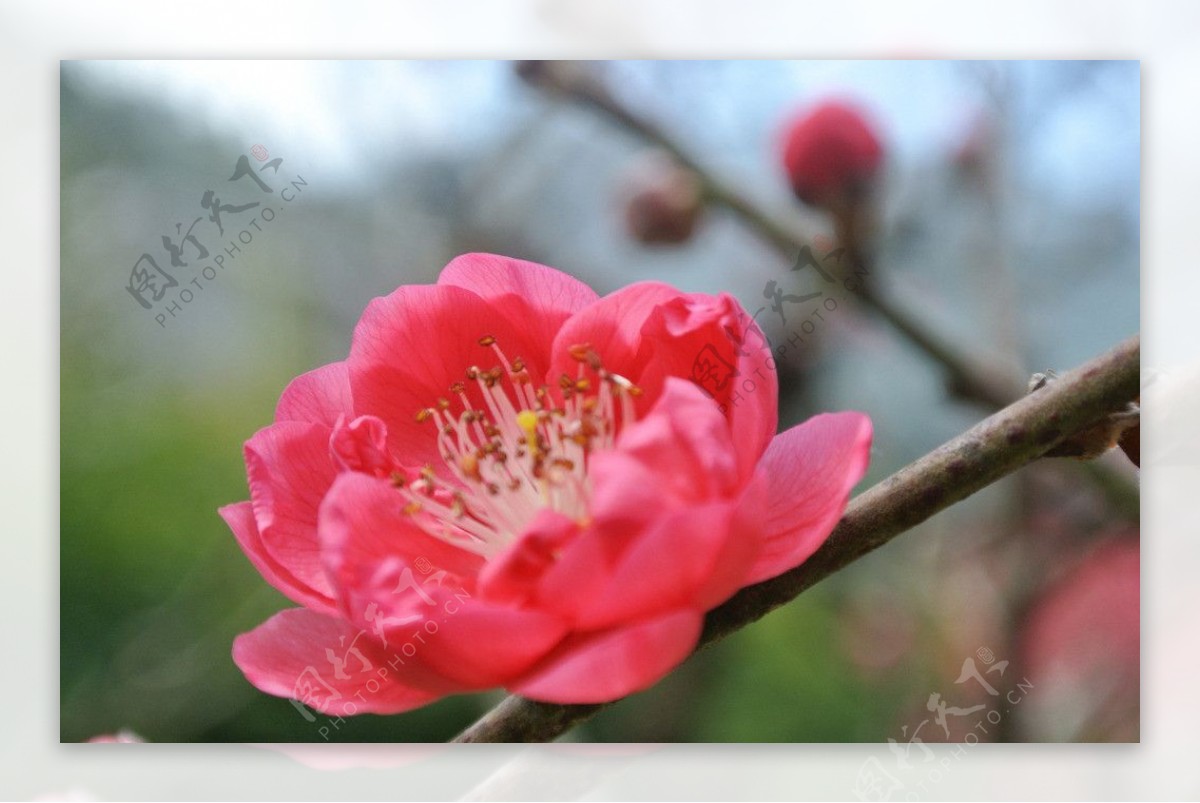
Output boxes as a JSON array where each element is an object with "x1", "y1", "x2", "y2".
[{"x1": 784, "y1": 100, "x2": 883, "y2": 206}]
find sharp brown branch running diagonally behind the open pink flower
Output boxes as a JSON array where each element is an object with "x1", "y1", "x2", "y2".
[{"x1": 455, "y1": 336, "x2": 1140, "y2": 742}]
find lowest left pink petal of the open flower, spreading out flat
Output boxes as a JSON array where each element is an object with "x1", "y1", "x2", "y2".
[{"x1": 233, "y1": 609, "x2": 457, "y2": 717}]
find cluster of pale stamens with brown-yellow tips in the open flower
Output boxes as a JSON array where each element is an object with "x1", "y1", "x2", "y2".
[{"x1": 392, "y1": 335, "x2": 642, "y2": 557}]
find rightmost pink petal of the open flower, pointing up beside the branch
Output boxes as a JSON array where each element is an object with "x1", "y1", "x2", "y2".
[{"x1": 745, "y1": 413, "x2": 871, "y2": 585}]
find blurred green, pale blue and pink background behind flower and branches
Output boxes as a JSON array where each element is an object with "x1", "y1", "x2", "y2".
[{"x1": 60, "y1": 61, "x2": 1140, "y2": 744}]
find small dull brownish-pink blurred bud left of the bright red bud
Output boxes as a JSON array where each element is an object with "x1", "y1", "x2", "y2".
[{"x1": 623, "y1": 152, "x2": 704, "y2": 245}]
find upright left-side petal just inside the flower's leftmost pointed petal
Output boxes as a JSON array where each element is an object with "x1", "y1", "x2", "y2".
[{"x1": 245, "y1": 421, "x2": 336, "y2": 597}]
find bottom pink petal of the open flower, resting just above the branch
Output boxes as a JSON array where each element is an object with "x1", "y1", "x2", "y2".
[{"x1": 508, "y1": 611, "x2": 703, "y2": 703}]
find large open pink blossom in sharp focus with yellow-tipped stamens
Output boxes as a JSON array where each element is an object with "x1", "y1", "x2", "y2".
[{"x1": 221, "y1": 254, "x2": 871, "y2": 715}]
